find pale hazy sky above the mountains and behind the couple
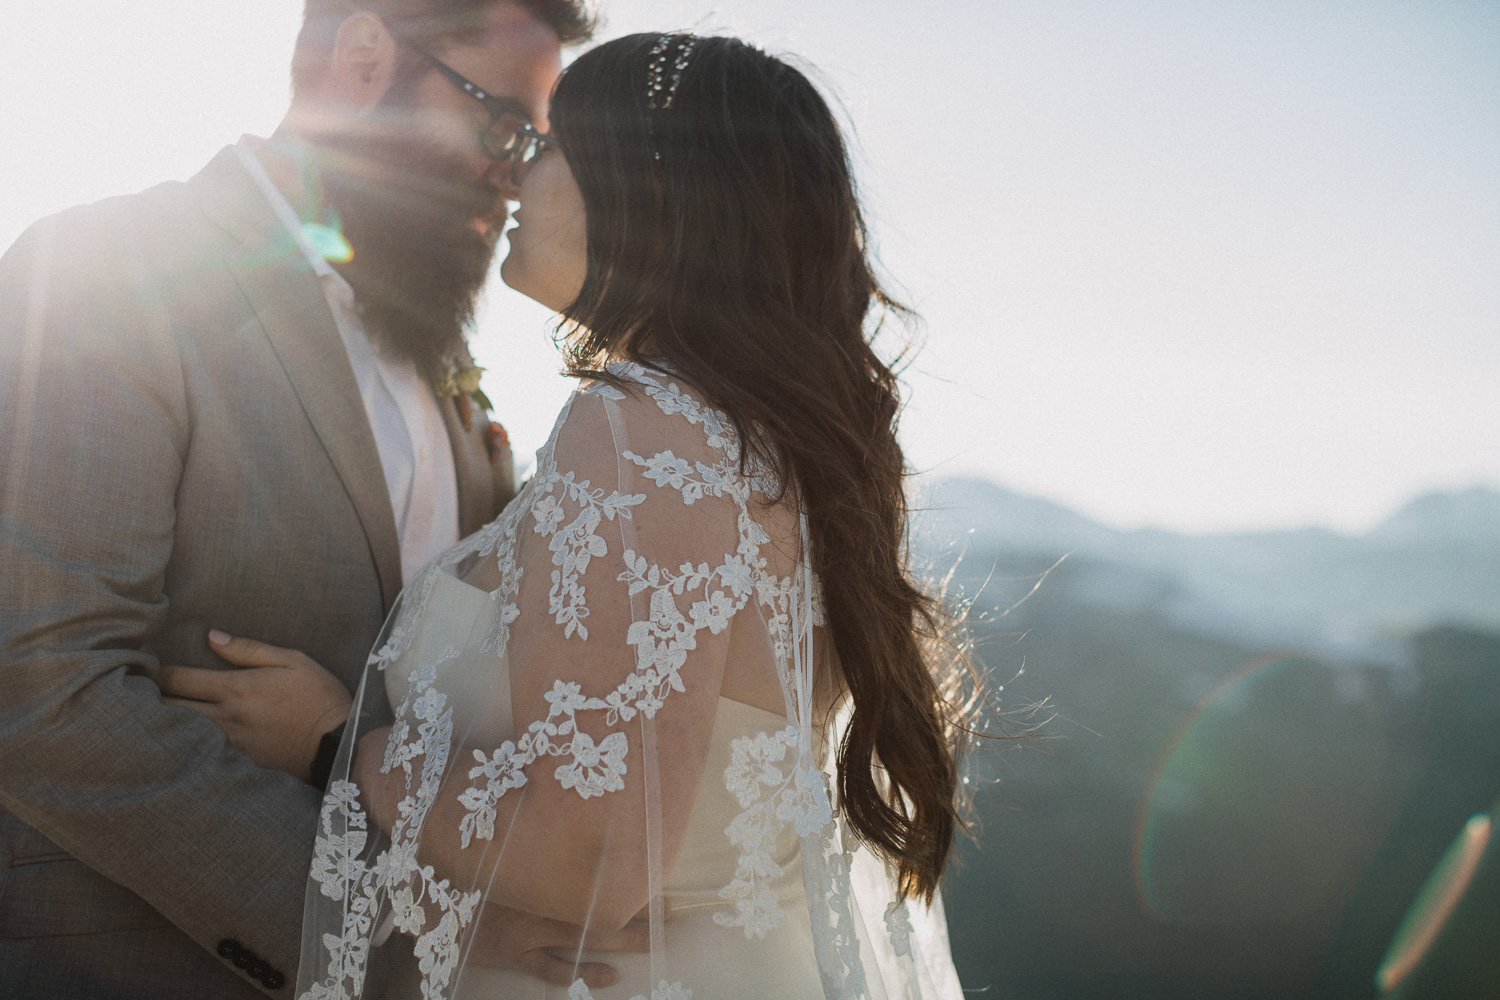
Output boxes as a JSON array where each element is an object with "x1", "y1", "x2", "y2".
[{"x1": 0, "y1": 0, "x2": 1500, "y2": 532}]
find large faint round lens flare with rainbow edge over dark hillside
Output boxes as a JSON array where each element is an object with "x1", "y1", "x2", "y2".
[{"x1": 1131, "y1": 654, "x2": 1391, "y2": 928}]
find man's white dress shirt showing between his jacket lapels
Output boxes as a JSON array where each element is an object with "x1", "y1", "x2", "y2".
[{"x1": 234, "y1": 136, "x2": 459, "y2": 586}]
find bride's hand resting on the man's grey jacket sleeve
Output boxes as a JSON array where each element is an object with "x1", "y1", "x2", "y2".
[{"x1": 156, "y1": 631, "x2": 354, "y2": 781}]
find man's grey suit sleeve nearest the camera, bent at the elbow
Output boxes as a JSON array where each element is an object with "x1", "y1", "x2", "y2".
[{"x1": 0, "y1": 210, "x2": 317, "y2": 996}]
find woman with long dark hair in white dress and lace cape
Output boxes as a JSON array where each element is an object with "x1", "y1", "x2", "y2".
[{"x1": 196, "y1": 34, "x2": 962, "y2": 1000}]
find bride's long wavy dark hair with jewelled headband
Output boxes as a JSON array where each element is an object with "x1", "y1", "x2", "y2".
[{"x1": 552, "y1": 34, "x2": 960, "y2": 898}]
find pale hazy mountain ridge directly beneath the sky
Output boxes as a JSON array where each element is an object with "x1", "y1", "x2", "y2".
[{"x1": 915, "y1": 478, "x2": 1500, "y2": 661}]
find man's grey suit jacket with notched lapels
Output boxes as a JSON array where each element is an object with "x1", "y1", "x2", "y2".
[{"x1": 0, "y1": 150, "x2": 513, "y2": 997}]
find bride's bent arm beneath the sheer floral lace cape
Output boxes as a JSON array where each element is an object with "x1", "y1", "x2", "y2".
[{"x1": 351, "y1": 386, "x2": 752, "y2": 928}]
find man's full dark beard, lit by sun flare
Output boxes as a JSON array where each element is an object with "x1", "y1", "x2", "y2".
[{"x1": 321, "y1": 125, "x2": 504, "y2": 378}]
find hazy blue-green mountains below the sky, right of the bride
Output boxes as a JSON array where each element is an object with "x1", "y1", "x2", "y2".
[{"x1": 917, "y1": 480, "x2": 1500, "y2": 1000}]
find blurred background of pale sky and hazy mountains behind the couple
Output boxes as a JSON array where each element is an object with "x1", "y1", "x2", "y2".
[{"x1": 0, "y1": 0, "x2": 1500, "y2": 1000}]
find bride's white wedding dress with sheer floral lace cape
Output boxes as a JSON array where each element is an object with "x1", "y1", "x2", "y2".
[{"x1": 297, "y1": 364, "x2": 962, "y2": 1000}]
